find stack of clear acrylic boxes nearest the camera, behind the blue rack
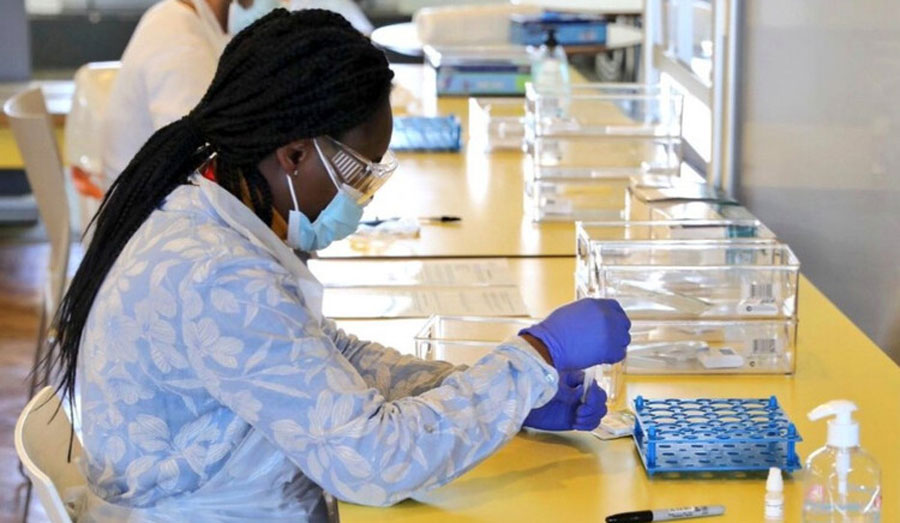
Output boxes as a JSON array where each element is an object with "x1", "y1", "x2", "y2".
[{"x1": 575, "y1": 221, "x2": 800, "y2": 374}]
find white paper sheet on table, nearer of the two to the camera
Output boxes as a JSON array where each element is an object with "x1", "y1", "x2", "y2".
[{"x1": 322, "y1": 285, "x2": 528, "y2": 318}]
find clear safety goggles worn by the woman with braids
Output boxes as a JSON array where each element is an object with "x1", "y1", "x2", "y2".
[{"x1": 313, "y1": 136, "x2": 397, "y2": 204}]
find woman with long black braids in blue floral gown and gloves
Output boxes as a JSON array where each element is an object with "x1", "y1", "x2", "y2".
[{"x1": 48, "y1": 10, "x2": 628, "y2": 522}]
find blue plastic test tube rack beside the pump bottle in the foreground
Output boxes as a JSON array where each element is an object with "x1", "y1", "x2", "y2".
[{"x1": 634, "y1": 396, "x2": 803, "y2": 476}]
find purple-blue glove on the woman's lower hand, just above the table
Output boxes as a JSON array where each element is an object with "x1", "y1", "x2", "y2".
[{"x1": 522, "y1": 371, "x2": 606, "y2": 430}]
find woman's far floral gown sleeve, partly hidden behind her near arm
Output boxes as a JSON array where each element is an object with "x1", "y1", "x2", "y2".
[{"x1": 323, "y1": 320, "x2": 467, "y2": 400}]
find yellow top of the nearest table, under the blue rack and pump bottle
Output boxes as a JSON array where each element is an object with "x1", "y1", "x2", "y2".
[{"x1": 340, "y1": 272, "x2": 900, "y2": 523}]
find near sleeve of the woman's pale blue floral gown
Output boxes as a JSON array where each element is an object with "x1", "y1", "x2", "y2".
[{"x1": 183, "y1": 261, "x2": 558, "y2": 506}]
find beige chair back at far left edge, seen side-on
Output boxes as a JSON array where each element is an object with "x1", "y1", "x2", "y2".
[{"x1": 3, "y1": 87, "x2": 72, "y2": 314}]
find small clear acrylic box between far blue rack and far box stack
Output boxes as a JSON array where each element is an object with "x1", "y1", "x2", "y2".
[{"x1": 469, "y1": 97, "x2": 525, "y2": 151}]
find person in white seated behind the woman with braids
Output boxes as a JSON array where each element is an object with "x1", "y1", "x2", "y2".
[{"x1": 103, "y1": 0, "x2": 281, "y2": 186}]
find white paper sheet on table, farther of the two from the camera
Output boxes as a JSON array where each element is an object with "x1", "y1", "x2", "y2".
[{"x1": 309, "y1": 258, "x2": 516, "y2": 287}]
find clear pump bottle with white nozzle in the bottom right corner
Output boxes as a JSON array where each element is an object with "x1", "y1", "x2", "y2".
[{"x1": 803, "y1": 400, "x2": 881, "y2": 523}]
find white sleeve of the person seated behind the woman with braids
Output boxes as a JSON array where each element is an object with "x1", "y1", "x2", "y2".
[{"x1": 141, "y1": 32, "x2": 219, "y2": 130}]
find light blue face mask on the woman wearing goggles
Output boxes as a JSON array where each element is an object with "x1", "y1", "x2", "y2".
[{"x1": 287, "y1": 175, "x2": 368, "y2": 252}]
